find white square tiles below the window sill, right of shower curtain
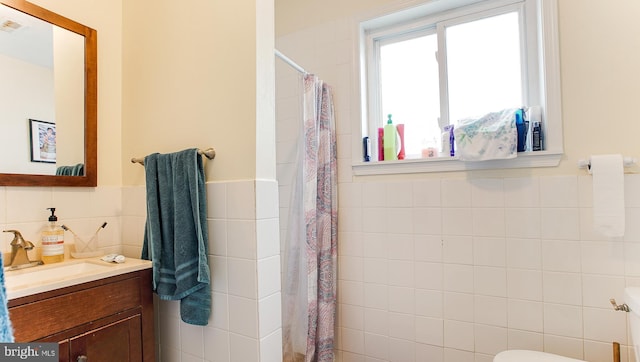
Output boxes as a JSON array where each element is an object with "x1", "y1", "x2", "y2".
[{"x1": 312, "y1": 172, "x2": 640, "y2": 361}]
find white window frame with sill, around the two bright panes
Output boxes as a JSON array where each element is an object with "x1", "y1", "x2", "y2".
[{"x1": 352, "y1": 0, "x2": 563, "y2": 175}]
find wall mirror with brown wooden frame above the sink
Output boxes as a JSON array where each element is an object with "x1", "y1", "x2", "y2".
[{"x1": 0, "y1": 0, "x2": 98, "y2": 187}]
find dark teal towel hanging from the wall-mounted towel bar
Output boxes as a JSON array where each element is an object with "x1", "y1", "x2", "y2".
[{"x1": 142, "y1": 148, "x2": 211, "y2": 325}]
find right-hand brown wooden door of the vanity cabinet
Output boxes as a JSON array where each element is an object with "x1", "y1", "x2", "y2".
[{"x1": 69, "y1": 314, "x2": 142, "y2": 362}]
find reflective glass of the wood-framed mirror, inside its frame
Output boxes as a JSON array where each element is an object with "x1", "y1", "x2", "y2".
[{"x1": 0, "y1": 5, "x2": 84, "y2": 175}]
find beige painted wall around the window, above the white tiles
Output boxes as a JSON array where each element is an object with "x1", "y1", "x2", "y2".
[{"x1": 276, "y1": 0, "x2": 640, "y2": 178}]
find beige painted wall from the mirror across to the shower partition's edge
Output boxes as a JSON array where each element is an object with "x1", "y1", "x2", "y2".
[{"x1": 26, "y1": 0, "x2": 275, "y2": 186}]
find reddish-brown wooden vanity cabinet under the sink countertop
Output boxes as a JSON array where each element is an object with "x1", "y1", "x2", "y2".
[{"x1": 9, "y1": 269, "x2": 155, "y2": 362}]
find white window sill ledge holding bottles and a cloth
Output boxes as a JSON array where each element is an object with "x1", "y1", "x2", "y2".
[{"x1": 352, "y1": 151, "x2": 562, "y2": 176}]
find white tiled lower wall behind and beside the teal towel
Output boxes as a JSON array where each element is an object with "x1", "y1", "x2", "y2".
[{"x1": 122, "y1": 180, "x2": 282, "y2": 362}]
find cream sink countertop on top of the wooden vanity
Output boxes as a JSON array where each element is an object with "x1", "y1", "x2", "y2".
[{"x1": 4, "y1": 257, "x2": 151, "y2": 300}]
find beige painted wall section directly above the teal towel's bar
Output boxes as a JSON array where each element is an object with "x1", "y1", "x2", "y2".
[{"x1": 121, "y1": 0, "x2": 264, "y2": 185}]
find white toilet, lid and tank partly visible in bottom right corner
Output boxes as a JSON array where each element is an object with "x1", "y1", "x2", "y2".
[{"x1": 493, "y1": 287, "x2": 640, "y2": 362}]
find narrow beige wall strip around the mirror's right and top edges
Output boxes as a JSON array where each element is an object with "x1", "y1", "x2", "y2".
[{"x1": 31, "y1": 0, "x2": 122, "y2": 186}]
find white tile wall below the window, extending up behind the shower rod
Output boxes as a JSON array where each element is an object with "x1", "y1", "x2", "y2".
[{"x1": 276, "y1": 20, "x2": 640, "y2": 362}]
